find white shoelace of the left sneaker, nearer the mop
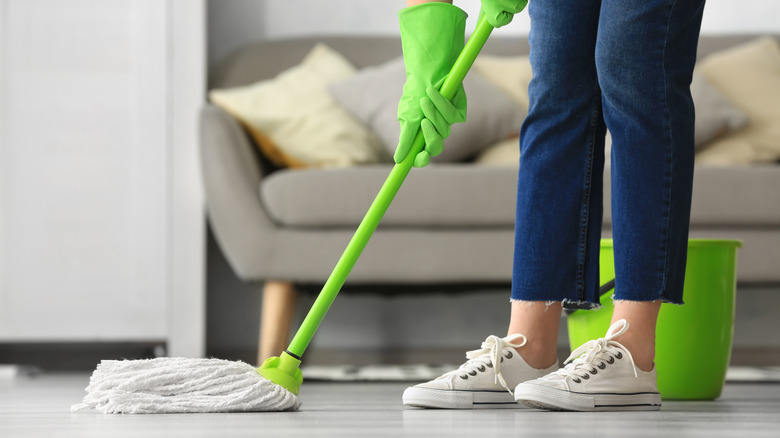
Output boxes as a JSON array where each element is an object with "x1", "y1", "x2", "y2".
[{"x1": 442, "y1": 334, "x2": 528, "y2": 393}]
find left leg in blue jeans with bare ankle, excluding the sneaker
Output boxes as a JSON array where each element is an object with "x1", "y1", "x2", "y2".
[{"x1": 508, "y1": 0, "x2": 606, "y2": 368}]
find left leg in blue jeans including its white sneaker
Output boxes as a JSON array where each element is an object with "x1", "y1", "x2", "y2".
[{"x1": 403, "y1": 0, "x2": 605, "y2": 408}]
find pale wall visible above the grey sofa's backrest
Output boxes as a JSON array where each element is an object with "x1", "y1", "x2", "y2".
[{"x1": 208, "y1": 0, "x2": 780, "y2": 70}]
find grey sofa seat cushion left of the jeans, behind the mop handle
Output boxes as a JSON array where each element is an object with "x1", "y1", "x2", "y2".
[{"x1": 260, "y1": 164, "x2": 517, "y2": 229}]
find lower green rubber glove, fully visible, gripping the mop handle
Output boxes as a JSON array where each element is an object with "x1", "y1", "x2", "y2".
[{"x1": 393, "y1": 2, "x2": 466, "y2": 167}]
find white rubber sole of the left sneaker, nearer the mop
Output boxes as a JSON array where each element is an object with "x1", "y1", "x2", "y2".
[{"x1": 403, "y1": 386, "x2": 525, "y2": 409}]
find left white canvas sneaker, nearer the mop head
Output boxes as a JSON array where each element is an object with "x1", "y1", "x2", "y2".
[{"x1": 403, "y1": 334, "x2": 558, "y2": 409}]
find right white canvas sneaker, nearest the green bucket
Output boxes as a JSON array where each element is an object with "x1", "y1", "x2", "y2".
[{"x1": 515, "y1": 319, "x2": 661, "y2": 411}]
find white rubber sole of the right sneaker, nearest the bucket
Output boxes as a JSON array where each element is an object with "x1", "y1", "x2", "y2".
[{"x1": 515, "y1": 383, "x2": 661, "y2": 412}]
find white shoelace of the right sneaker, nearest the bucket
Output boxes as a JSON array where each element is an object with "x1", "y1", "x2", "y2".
[{"x1": 550, "y1": 319, "x2": 638, "y2": 383}]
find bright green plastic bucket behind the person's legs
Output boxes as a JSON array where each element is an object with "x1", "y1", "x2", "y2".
[{"x1": 568, "y1": 239, "x2": 742, "y2": 400}]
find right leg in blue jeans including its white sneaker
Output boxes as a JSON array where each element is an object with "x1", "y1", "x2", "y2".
[{"x1": 515, "y1": 0, "x2": 704, "y2": 411}]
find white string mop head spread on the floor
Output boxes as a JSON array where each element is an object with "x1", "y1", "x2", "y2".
[{"x1": 71, "y1": 357, "x2": 300, "y2": 414}]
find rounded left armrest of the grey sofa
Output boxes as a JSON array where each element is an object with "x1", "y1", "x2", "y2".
[{"x1": 200, "y1": 105, "x2": 276, "y2": 281}]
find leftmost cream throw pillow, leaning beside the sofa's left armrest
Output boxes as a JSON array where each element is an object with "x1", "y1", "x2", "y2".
[{"x1": 209, "y1": 44, "x2": 387, "y2": 167}]
